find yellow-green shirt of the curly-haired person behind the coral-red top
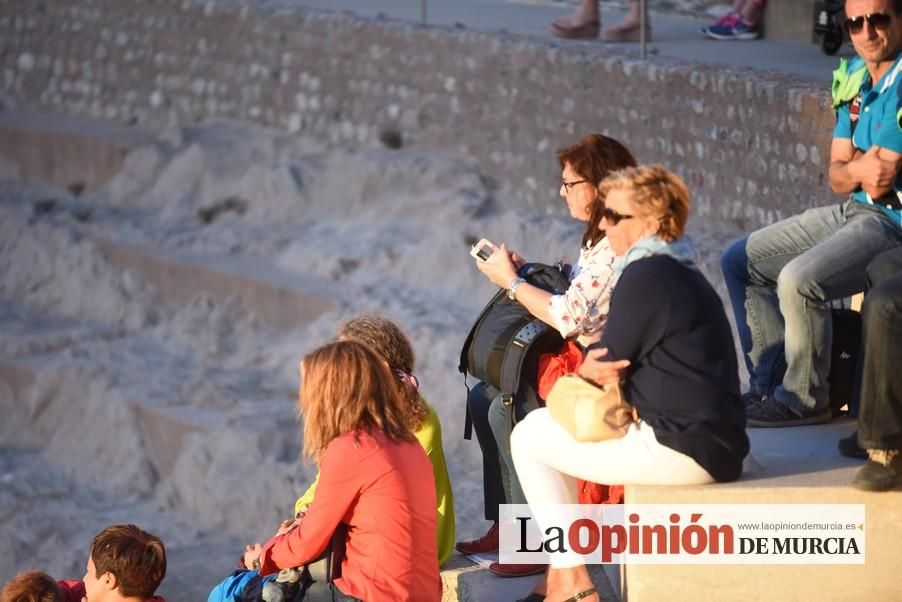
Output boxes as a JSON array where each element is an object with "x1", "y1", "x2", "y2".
[{"x1": 294, "y1": 401, "x2": 455, "y2": 565}]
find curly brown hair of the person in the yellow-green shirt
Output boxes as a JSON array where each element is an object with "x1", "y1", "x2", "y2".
[{"x1": 338, "y1": 314, "x2": 428, "y2": 432}]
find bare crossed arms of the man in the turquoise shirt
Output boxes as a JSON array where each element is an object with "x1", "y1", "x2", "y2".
[{"x1": 827, "y1": 138, "x2": 902, "y2": 199}]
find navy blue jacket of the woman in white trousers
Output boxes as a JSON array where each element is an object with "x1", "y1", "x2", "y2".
[{"x1": 589, "y1": 255, "x2": 749, "y2": 481}]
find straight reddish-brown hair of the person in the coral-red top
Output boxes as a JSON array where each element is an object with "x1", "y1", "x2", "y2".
[{"x1": 298, "y1": 341, "x2": 416, "y2": 459}]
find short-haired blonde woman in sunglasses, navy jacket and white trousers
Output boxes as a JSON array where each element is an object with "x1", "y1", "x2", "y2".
[{"x1": 511, "y1": 166, "x2": 749, "y2": 602}]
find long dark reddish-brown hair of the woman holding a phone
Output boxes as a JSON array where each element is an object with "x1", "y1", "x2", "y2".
[{"x1": 557, "y1": 134, "x2": 636, "y2": 247}]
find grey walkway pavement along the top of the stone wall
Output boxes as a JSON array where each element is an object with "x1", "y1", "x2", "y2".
[{"x1": 270, "y1": 0, "x2": 854, "y2": 84}]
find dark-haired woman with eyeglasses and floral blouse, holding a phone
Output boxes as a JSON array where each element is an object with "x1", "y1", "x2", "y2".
[{"x1": 466, "y1": 134, "x2": 636, "y2": 577}]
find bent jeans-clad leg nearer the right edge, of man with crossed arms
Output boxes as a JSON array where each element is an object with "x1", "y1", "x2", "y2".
[{"x1": 774, "y1": 203, "x2": 902, "y2": 414}]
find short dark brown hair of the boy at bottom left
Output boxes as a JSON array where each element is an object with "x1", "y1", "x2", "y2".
[{"x1": 91, "y1": 525, "x2": 166, "y2": 600}]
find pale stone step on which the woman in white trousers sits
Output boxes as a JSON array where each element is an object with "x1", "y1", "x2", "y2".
[{"x1": 613, "y1": 419, "x2": 902, "y2": 602}]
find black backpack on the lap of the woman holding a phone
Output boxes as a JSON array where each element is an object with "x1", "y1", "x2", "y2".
[{"x1": 457, "y1": 263, "x2": 570, "y2": 439}]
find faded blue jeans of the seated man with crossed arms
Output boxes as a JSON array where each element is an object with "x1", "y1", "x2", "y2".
[{"x1": 721, "y1": 200, "x2": 902, "y2": 412}]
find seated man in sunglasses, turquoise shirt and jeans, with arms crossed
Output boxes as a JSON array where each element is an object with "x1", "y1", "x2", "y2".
[{"x1": 721, "y1": 0, "x2": 902, "y2": 427}]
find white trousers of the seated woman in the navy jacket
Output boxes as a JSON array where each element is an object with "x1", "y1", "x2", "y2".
[{"x1": 511, "y1": 408, "x2": 714, "y2": 568}]
